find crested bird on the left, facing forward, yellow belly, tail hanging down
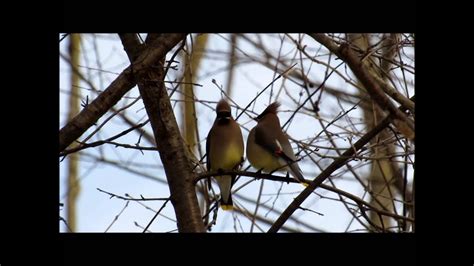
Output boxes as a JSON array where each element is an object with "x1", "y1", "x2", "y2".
[{"x1": 206, "y1": 99, "x2": 244, "y2": 210}]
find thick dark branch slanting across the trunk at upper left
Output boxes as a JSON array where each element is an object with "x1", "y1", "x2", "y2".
[{"x1": 59, "y1": 34, "x2": 185, "y2": 152}]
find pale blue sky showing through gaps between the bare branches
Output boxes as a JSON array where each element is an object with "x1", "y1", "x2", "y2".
[{"x1": 59, "y1": 34, "x2": 414, "y2": 232}]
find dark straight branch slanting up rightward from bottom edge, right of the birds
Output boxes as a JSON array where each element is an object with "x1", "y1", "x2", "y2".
[{"x1": 268, "y1": 96, "x2": 414, "y2": 233}]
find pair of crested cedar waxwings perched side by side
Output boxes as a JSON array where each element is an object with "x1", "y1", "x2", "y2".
[{"x1": 206, "y1": 99, "x2": 304, "y2": 210}]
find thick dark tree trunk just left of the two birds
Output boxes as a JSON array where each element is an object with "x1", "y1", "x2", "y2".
[{"x1": 120, "y1": 34, "x2": 205, "y2": 232}]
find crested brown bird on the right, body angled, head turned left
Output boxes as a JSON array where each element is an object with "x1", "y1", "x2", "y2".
[{"x1": 247, "y1": 102, "x2": 307, "y2": 186}]
